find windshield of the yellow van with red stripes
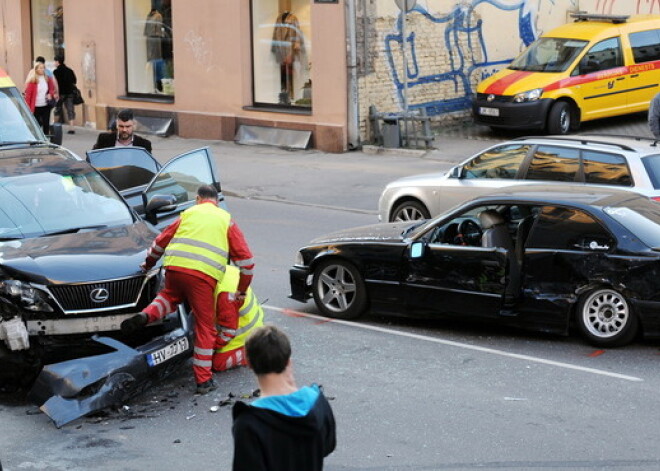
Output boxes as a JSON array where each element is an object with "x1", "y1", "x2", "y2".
[{"x1": 508, "y1": 38, "x2": 587, "y2": 72}]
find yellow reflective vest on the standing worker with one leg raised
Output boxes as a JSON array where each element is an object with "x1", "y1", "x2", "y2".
[{"x1": 163, "y1": 203, "x2": 231, "y2": 281}]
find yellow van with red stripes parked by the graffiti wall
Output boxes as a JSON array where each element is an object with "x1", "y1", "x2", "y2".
[{"x1": 472, "y1": 13, "x2": 660, "y2": 134}]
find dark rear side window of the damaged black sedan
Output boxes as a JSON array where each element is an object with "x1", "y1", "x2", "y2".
[{"x1": 525, "y1": 206, "x2": 613, "y2": 250}]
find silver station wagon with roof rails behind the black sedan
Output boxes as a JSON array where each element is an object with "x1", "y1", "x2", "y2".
[{"x1": 378, "y1": 135, "x2": 660, "y2": 222}]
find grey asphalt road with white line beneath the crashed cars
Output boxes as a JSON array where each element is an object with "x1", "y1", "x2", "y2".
[{"x1": 0, "y1": 115, "x2": 660, "y2": 471}]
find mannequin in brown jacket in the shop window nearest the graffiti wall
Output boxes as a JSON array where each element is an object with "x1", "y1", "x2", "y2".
[{"x1": 271, "y1": 10, "x2": 305, "y2": 105}]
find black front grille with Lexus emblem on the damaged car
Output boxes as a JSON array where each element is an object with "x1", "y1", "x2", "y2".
[{"x1": 48, "y1": 275, "x2": 157, "y2": 311}]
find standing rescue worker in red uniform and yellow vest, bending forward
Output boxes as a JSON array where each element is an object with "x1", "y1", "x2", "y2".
[{"x1": 121, "y1": 185, "x2": 254, "y2": 394}]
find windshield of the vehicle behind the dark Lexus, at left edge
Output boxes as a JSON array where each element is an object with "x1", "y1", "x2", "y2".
[{"x1": 0, "y1": 87, "x2": 46, "y2": 145}]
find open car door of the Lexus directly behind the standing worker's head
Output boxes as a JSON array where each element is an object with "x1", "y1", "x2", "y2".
[{"x1": 141, "y1": 147, "x2": 224, "y2": 229}]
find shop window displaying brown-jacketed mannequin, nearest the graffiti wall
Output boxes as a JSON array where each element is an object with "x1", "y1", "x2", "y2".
[{"x1": 252, "y1": 0, "x2": 312, "y2": 108}]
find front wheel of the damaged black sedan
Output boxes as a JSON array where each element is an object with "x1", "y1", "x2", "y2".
[{"x1": 312, "y1": 259, "x2": 367, "y2": 319}]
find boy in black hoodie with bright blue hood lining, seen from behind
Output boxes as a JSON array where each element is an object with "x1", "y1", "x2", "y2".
[{"x1": 232, "y1": 325, "x2": 336, "y2": 471}]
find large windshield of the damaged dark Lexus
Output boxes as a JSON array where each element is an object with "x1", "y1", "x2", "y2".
[{"x1": 0, "y1": 156, "x2": 133, "y2": 240}]
